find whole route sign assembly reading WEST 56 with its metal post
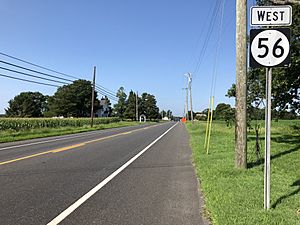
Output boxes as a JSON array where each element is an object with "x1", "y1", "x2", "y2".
[{"x1": 249, "y1": 5, "x2": 292, "y2": 209}]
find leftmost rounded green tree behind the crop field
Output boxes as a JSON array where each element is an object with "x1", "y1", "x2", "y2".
[{"x1": 5, "y1": 92, "x2": 48, "y2": 117}]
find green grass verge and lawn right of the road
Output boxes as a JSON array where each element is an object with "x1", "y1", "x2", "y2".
[{"x1": 186, "y1": 120, "x2": 300, "y2": 225}]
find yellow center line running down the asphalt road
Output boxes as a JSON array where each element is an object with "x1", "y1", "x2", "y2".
[{"x1": 0, "y1": 124, "x2": 166, "y2": 166}]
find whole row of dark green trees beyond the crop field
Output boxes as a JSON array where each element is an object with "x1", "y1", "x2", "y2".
[{"x1": 5, "y1": 80, "x2": 173, "y2": 120}]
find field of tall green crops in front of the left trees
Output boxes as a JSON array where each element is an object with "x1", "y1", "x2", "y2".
[{"x1": 0, "y1": 117, "x2": 120, "y2": 131}]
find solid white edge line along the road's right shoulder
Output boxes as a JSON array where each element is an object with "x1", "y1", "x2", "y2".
[{"x1": 47, "y1": 122, "x2": 178, "y2": 225}]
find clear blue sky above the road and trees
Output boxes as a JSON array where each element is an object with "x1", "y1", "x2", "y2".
[{"x1": 0, "y1": 0, "x2": 253, "y2": 116}]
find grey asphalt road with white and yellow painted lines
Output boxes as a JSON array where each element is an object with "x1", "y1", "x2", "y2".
[{"x1": 0, "y1": 122, "x2": 203, "y2": 225}]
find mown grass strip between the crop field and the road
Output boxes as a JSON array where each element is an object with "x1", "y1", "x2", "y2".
[{"x1": 0, "y1": 121, "x2": 144, "y2": 143}]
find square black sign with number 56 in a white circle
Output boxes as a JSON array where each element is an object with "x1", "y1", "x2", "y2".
[{"x1": 250, "y1": 28, "x2": 291, "y2": 68}]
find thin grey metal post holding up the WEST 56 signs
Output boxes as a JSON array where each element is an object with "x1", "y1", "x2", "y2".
[{"x1": 264, "y1": 68, "x2": 272, "y2": 209}]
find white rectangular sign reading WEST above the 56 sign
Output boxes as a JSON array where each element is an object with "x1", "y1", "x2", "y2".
[{"x1": 250, "y1": 5, "x2": 292, "y2": 26}]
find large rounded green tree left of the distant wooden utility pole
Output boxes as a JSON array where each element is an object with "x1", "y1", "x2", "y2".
[{"x1": 47, "y1": 80, "x2": 99, "y2": 117}]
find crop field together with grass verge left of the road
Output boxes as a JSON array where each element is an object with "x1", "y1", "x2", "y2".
[{"x1": 0, "y1": 118, "x2": 143, "y2": 143}]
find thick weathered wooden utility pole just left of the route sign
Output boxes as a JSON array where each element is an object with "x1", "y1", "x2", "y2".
[{"x1": 235, "y1": 0, "x2": 247, "y2": 169}]
